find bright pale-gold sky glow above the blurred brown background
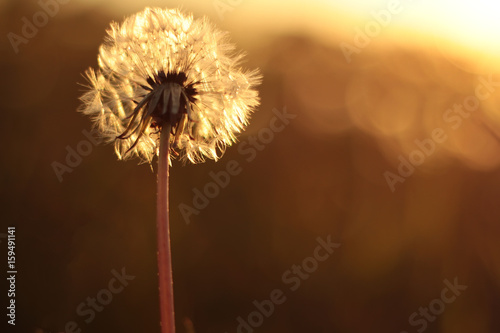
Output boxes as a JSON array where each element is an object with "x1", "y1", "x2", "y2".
[{"x1": 56, "y1": 0, "x2": 500, "y2": 66}]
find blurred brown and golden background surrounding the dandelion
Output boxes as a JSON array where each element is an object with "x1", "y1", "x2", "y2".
[{"x1": 0, "y1": 0, "x2": 500, "y2": 333}]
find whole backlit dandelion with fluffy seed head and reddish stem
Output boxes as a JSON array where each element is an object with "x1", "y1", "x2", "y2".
[{"x1": 81, "y1": 8, "x2": 260, "y2": 333}]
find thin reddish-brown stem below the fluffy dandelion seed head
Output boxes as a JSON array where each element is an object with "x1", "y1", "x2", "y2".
[{"x1": 156, "y1": 126, "x2": 175, "y2": 333}]
